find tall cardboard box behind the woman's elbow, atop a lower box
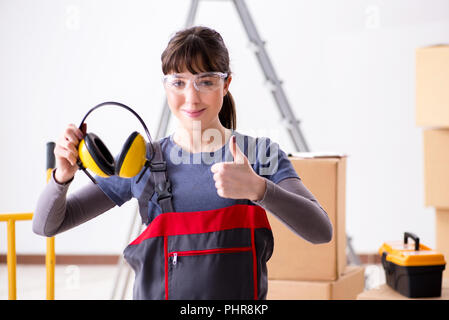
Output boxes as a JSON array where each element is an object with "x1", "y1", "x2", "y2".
[{"x1": 268, "y1": 153, "x2": 346, "y2": 281}]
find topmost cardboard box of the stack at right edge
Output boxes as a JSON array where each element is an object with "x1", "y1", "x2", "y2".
[{"x1": 416, "y1": 45, "x2": 449, "y2": 127}]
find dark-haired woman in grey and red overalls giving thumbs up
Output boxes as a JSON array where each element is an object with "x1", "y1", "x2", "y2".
[{"x1": 33, "y1": 27, "x2": 332, "y2": 299}]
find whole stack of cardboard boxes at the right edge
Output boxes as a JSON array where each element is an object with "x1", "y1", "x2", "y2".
[{"x1": 416, "y1": 45, "x2": 449, "y2": 278}]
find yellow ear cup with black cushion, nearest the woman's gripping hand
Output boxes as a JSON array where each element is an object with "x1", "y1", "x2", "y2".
[{"x1": 78, "y1": 133, "x2": 114, "y2": 177}]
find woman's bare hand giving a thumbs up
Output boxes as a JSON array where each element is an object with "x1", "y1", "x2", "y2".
[{"x1": 211, "y1": 136, "x2": 266, "y2": 201}]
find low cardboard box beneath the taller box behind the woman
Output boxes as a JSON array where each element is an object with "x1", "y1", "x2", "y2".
[{"x1": 267, "y1": 266, "x2": 365, "y2": 300}]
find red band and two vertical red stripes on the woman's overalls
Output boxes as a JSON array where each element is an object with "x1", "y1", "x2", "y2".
[{"x1": 130, "y1": 204, "x2": 271, "y2": 300}]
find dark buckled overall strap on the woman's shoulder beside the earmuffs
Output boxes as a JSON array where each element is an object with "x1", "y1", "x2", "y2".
[{"x1": 138, "y1": 141, "x2": 174, "y2": 224}]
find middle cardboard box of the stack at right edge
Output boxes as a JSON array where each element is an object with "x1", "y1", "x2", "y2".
[{"x1": 423, "y1": 129, "x2": 449, "y2": 208}]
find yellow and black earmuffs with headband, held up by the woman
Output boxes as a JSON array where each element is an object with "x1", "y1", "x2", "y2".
[{"x1": 77, "y1": 102, "x2": 154, "y2": 183}]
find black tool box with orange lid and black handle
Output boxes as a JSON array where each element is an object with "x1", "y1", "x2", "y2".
[{"x1": 379, "y1": 232, "x2": 446, "y2": 298}]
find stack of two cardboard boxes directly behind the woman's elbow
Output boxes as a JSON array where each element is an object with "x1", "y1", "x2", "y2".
[{"x1": 267, "y1": 153, "x2": 364, "y2": 300}]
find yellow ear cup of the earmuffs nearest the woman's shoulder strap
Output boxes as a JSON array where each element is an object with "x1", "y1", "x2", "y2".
[{"x1": 115, "y1": 131, "x2": 146, "y2": 178}]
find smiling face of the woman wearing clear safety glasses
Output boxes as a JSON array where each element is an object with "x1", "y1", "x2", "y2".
[{"x1": 164, "y1": 69, "x2": 231, "y2": 131}]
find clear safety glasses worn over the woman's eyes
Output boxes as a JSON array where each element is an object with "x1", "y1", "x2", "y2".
[{"x1": 163, "y1": 72, "x2": 227, "y2": 94}]
